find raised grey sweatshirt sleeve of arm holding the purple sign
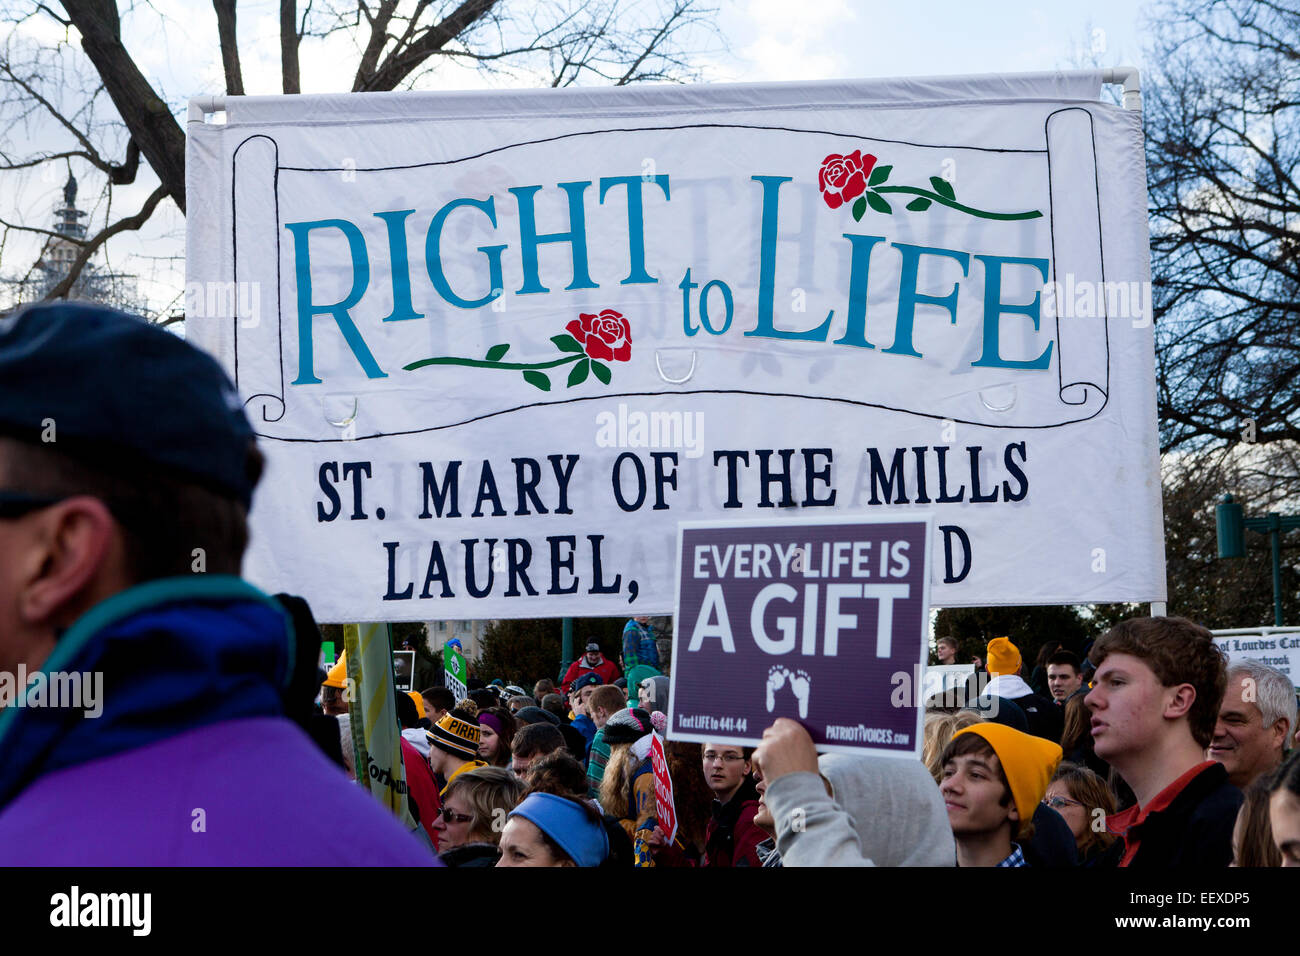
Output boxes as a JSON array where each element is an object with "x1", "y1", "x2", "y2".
[{"x1": 763, "y1": 773, "x2": 875, "y2": 866}]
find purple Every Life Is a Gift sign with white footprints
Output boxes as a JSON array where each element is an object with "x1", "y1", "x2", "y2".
[{"x1": 668, "y1": 514, "x2": 933, "y2": 757}]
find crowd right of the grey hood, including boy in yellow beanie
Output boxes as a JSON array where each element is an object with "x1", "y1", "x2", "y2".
[{"x1": 923, "y1": 618, "x2": 1300, "y2": 869}]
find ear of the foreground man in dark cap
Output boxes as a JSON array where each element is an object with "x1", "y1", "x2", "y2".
[{"x1": 18, "y1": 494, "x2": 121, "y2": 624}]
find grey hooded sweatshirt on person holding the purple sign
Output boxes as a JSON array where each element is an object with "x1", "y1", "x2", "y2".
[{"x1": 763, "y1": 753, "x2": 957, "y2": 866}]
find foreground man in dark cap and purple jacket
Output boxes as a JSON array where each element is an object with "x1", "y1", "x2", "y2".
[{"x1": 0, "y1": 303, "x2": 433, "y2": 866}]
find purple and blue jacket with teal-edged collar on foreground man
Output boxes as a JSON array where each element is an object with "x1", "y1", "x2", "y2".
[{"x1": 0, "y1": 575, "x2": 437, "y2": 866}]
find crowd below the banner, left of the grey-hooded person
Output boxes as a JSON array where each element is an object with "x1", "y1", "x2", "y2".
[{"x1": 332, "y1": 632, "x2": 779, "y2": 866}]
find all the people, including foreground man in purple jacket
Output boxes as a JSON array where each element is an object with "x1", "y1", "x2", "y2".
[{"x1": 0, "y1": 303, "x2": 1300, "y2": 869}]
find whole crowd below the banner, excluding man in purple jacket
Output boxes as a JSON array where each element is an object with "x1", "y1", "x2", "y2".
[{"x1": 330, "y1": 618, "x2": 1300, "y2": 869}]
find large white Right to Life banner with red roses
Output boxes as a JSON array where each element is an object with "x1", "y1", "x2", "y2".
[{"x1": 186, "y1": 73, "x2": 1165, "y2": 620}]
